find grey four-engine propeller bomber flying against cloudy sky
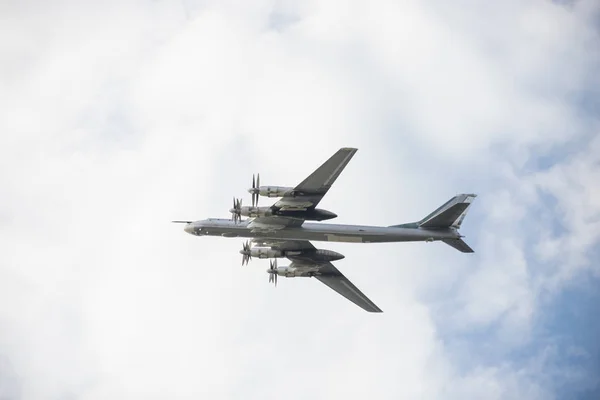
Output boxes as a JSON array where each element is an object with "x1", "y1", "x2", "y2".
[{"x1": 173, "y1": 147, "x2": 477, "y2": 312}]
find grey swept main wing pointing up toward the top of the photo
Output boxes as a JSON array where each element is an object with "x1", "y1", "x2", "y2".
[{"x1": 274, "y1": 147, "x2": 358, "y2": 210}]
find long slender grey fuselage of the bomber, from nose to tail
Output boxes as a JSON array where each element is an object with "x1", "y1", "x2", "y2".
[{"x1": 185, "y1": 218, "x2": 460, "y2": 243}]
